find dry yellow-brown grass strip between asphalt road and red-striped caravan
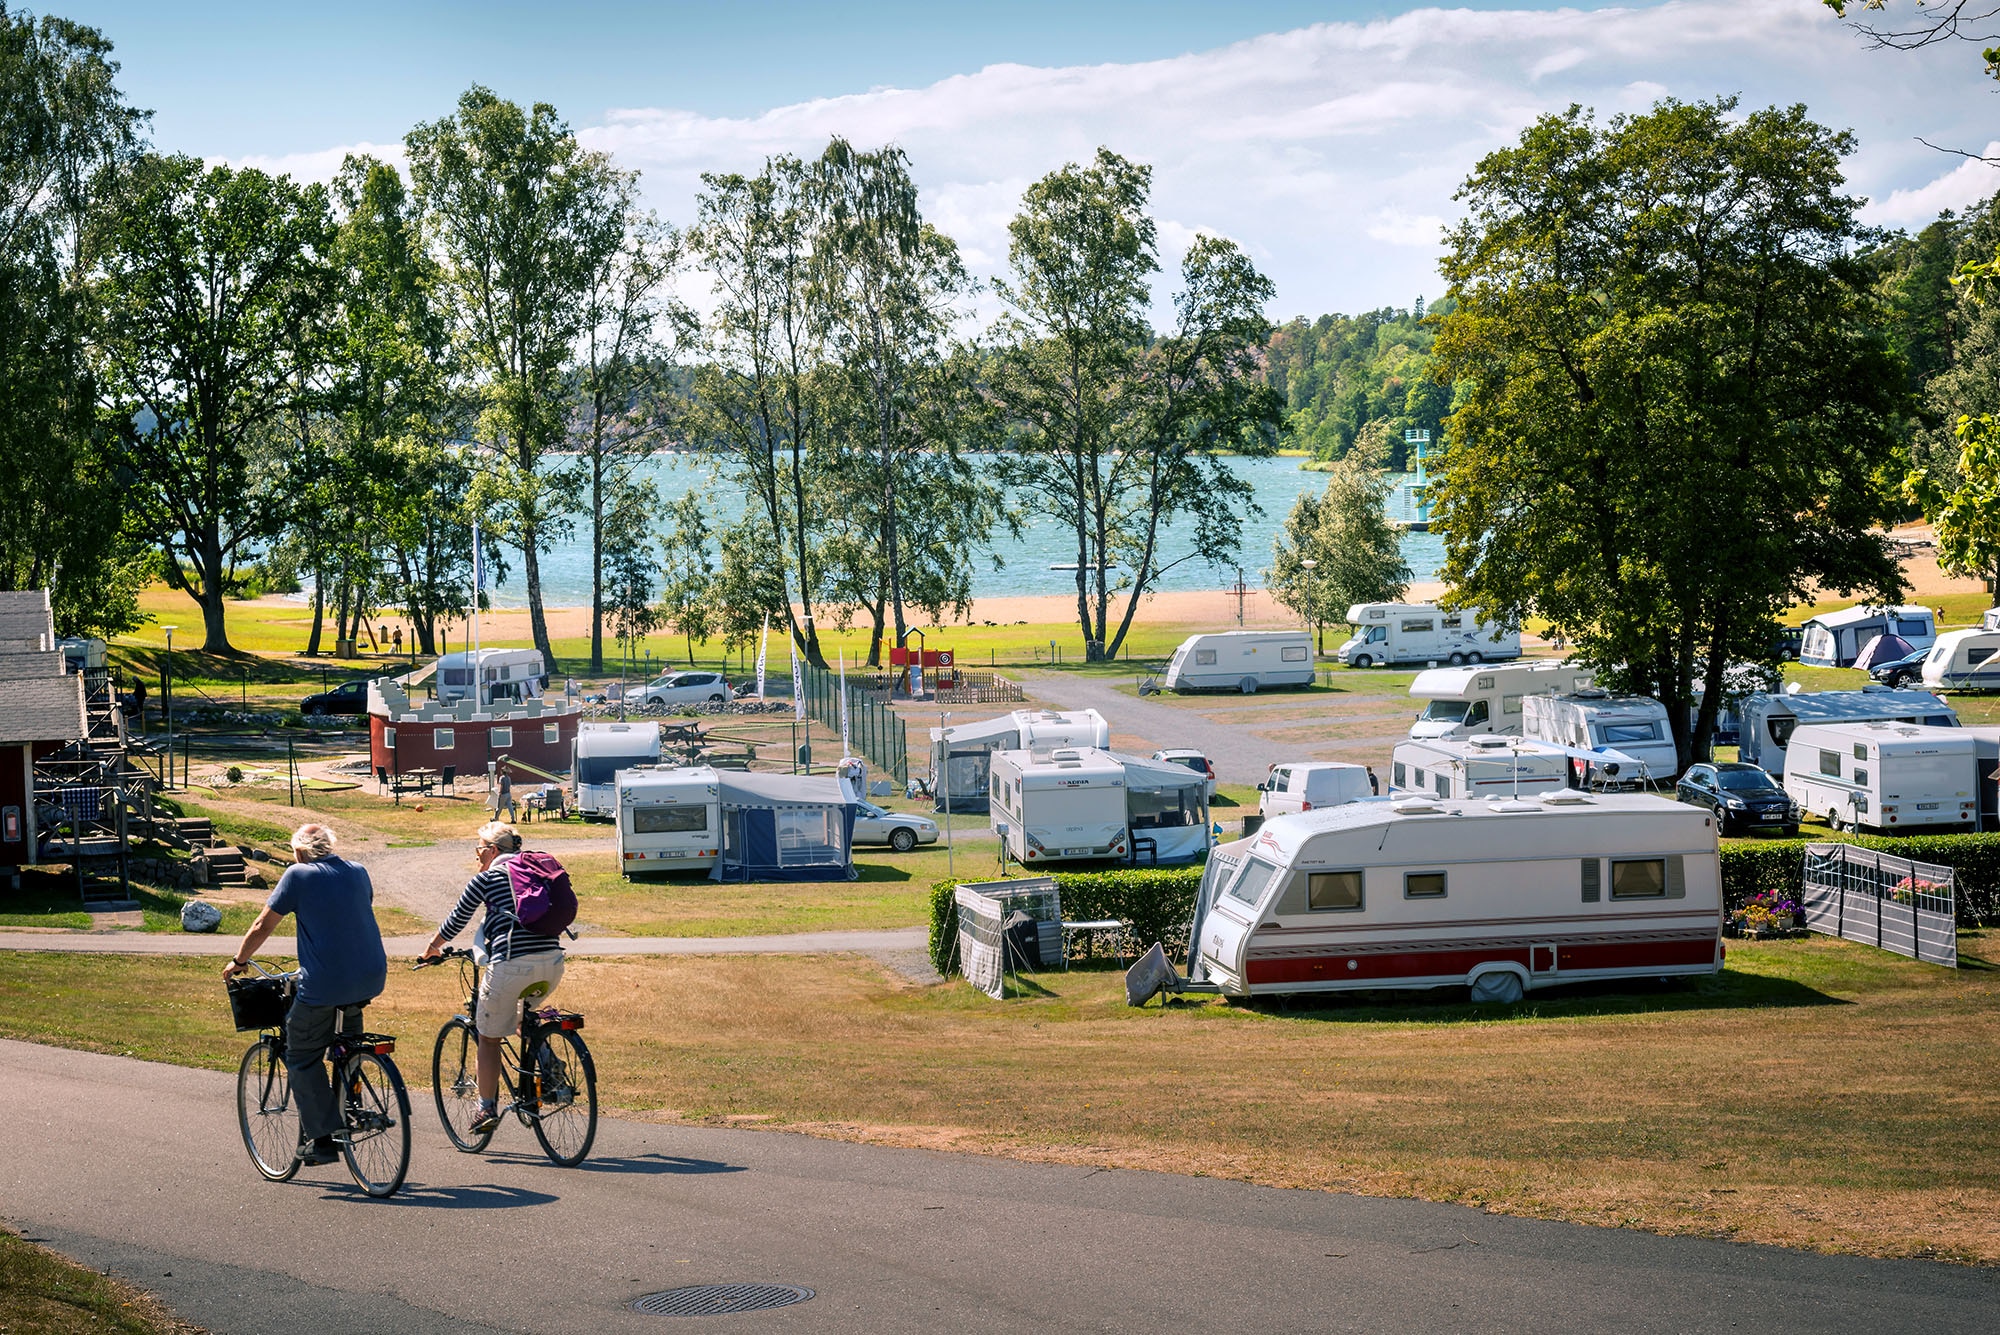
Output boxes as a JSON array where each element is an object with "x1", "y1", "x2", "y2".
[{"x1": 0, "y1": 935, "x2": 2000, "y2": 1263}]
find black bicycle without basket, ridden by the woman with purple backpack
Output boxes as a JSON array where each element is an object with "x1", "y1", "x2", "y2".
[{"x1": 412, "y1": 947, "x2": 598, "y2": 1167}]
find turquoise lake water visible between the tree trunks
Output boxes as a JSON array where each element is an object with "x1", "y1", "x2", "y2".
[{"x1": 488, "y1": 454, "x2": 1444, "y2": 608}]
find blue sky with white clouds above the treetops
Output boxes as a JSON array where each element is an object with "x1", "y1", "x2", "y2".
[{"x1": 50, "y1": 0, "x2": 2000, "y2": 316}]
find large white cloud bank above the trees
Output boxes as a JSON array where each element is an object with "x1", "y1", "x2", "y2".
[{"x1": 219, "y1": 0, "x2": 1994, "y2": 316}]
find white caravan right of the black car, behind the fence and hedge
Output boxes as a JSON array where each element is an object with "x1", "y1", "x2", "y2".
[{"x1": 1784, "y1": 723, "x2": 1980, "y2": 833}]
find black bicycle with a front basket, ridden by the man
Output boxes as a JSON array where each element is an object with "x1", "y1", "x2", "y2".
[{"x1": 228, "y1": 959, "x2": 410, "y2": 1195}]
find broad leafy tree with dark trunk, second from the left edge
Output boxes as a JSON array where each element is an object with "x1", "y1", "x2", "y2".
[{"x1": 96, "y1": 156, "x2": 334, "y2": 654}]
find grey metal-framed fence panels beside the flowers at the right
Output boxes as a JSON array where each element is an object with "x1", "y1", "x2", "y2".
[{"x1": 1800, "y1": 843, "x2": 1958, "y2": 969}]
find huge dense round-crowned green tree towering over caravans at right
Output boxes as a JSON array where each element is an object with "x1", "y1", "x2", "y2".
[{"x1": 1432, "y1": 100, "x2": 1908, "y2": 763}]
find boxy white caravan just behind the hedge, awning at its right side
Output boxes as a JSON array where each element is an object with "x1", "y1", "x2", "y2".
[{"x1": 990, "y1": 747, "x2": 1128, "y2": 867}]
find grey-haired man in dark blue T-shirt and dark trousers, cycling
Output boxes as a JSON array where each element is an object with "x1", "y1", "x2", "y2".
[{"x1": 222, "y1": 825, "x2": 388, "y2": 1165}]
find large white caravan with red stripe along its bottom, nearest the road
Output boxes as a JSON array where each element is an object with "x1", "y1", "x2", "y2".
[{"x1": 1188, "y1": 789, "x2": 1722, "y2": 1001}]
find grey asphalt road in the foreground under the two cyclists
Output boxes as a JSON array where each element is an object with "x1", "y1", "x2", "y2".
[{"x1": 0, "y1": 1043, "x2": 2000, "y2": 1335}]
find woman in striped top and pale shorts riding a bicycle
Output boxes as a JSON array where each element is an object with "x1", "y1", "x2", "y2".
[{"x1": 424, "y1": 821, "x2": 562, "y2": 1135}]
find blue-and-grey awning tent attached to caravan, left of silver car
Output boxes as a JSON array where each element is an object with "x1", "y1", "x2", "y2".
[{"x1": 708, "y1": 769, "x2": 858, "y2": 881}]
